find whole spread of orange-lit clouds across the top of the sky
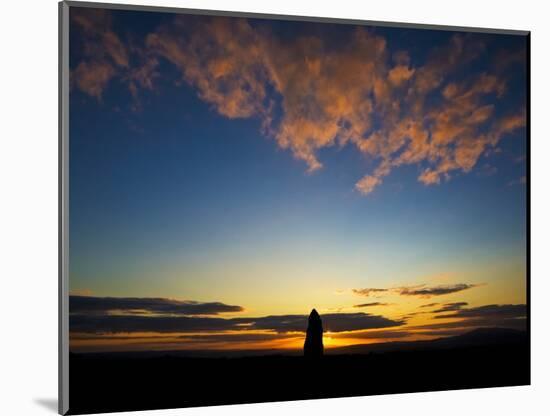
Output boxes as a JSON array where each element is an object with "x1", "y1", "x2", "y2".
[{"x1": 72, "y1": 12, "x2": 526, "y2": 195}]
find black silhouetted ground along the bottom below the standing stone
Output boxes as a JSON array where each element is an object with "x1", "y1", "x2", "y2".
[{"x1": 69, "y1": 331, "x2": 529, "y2": 414}]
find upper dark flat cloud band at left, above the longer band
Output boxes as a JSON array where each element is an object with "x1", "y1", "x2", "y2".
[{"x1": 69, "y1": 295, "x2": 244, "y2": 315}]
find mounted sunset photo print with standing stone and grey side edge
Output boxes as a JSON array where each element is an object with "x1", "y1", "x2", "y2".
[{"x1": 60, "y1": 2, "x2": 530, "y2": 414}]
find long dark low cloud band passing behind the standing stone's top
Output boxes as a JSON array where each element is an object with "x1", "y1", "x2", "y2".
[{"x1": 69, "y1": 313, "x2": 404, "y2": 334}]
